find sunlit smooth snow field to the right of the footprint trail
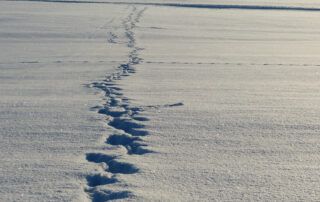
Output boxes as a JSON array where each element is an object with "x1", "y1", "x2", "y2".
[{"x1": 119, "y1": 7, "x2": 320, "y2": 201}]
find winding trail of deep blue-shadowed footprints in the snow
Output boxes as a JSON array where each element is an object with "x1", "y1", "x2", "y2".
[{"x1": 85, "y1": 7, "x2": 147, "y2": 202}]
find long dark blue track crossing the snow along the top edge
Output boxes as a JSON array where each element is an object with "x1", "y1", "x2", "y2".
[{"x1": 5, "y1": 0, "x2": 320, "y2": 12}]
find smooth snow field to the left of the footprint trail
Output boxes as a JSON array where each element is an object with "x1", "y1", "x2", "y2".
[{"x1": 0, "y1": 1, "x2": 129, "y2": 202}]
